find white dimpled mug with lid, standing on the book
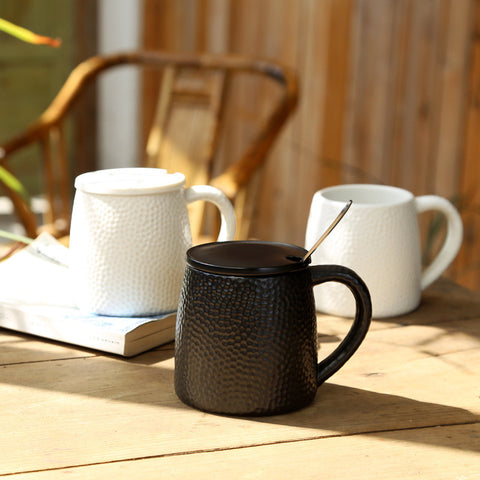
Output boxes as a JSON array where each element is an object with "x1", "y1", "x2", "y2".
[{"x1": 70, "y1": 168, "x2": 236, "y2": 316}]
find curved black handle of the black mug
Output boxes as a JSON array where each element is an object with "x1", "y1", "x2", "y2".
[{"x1": 309, "y1": 265, "x2": 372, "y2": 386}]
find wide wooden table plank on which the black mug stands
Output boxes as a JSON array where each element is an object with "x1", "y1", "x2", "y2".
[{"x1": 0, "y1": 344, "x2": 480, "y2": 474}]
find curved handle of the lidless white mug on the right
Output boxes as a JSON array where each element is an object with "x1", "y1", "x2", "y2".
[{"x1": 415, "y1": 195, "x2": 463, "y2": 290}]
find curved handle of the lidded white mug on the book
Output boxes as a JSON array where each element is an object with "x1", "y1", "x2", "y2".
[{"x1": 185, "y1": 185, "x2": 237, "y2": 242}]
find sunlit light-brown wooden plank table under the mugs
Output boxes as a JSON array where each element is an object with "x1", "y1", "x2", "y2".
[{"x1": 0, "y1": 280, "x2": 480, "y2": 480}]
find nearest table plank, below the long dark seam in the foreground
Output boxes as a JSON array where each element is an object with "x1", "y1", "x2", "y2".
[{"x1": 5, "y1": 424, "x2": 480, "y2": 480}]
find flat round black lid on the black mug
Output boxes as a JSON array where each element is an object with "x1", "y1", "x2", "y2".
[{"x1": 187, "y1": 240, "x2": 310, "y2": 276}]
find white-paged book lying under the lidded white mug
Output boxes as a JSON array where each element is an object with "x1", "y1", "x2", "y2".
[{"x1": 0, "y1": 233, "x2": 176, "y2": 357}]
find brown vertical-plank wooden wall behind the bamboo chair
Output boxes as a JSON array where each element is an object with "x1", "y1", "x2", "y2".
[{"x1": 144, "y1": 0, "x2": 480, "y2": 289}]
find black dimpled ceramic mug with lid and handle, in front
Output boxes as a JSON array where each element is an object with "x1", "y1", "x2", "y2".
[{"x1": 175, "y1": 241, "x2": 372, "y2": 415}]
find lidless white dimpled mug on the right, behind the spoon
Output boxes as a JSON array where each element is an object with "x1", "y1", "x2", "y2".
[{"x1": 305, "y1": 184, "x2": 463, "y2": 318}]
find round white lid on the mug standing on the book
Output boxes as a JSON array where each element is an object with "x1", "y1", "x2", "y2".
[{"x1": 75, "y1": 167, "x2": 185, "y2": 195}]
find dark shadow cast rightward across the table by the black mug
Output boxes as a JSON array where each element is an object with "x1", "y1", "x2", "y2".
[{"x1": 251, "y1": 383, "x2": 480, "y2": 452}]
